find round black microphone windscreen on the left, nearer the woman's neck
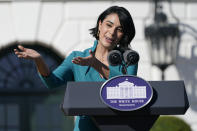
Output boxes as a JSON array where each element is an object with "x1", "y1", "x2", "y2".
[{"x1": 107, "y1": 50, "x2": 122, "y2": 66}]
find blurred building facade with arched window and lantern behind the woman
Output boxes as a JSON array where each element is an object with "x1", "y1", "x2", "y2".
[{"x1": 0, "y1": 0, "x2": 197, "y2": 131}]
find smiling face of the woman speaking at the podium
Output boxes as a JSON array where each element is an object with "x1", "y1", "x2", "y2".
[{"x1": 99, "y1": 13, "x2": 123, "y2": 49}]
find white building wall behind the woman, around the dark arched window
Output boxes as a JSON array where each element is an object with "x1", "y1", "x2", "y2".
[{"x1": 0, "y1": 0, "x2": 197, "y2": 131}]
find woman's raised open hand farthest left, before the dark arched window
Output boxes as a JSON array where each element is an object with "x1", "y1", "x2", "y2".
[{"x1": 14, "y1": 45, "x2": 41, "y2": 60}]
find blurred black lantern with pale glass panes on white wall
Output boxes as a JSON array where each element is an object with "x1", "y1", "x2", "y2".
[{"x1": 145, "y1": 0, "x2": 180, "y2": 80}]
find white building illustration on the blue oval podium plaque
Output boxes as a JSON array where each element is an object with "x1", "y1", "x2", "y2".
[{"x1": 106, "y1": 79, "x2": 146, "y2": 99}]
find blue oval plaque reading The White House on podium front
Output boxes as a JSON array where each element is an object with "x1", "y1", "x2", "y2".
[{"x1": 100, "y1": 75, "x2": 153, "y2": 111}]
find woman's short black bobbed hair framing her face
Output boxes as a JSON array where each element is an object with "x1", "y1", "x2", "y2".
[{"x1": 90, "y1": 6, "x2": 135, "y2": 48}]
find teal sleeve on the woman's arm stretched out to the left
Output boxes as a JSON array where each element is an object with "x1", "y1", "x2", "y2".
[{"x1": 39, "y1": 53, "x2": 74, "y2": 89}]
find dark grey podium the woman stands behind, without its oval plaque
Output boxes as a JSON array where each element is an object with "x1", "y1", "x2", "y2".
[{"x1": 61, "y1": 81, "x2": 189, "y2": 131}]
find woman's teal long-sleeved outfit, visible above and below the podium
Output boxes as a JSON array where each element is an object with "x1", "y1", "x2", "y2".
[{"x1": 39, "y1": 40, "x2": 138, "y2": 131}]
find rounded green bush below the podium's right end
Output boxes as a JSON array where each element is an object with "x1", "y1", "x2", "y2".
[{"x1": 150, "y1": 116, "x2": 191, "y2": 131}]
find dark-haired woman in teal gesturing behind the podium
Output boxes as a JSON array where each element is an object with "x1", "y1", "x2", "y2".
[{"x1": 14, "y1": 6, "x2": 137, "y2": 131}]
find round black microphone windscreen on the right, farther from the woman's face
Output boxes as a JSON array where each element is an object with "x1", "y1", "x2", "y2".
[{"x1": 123, "y1": 50, "x2": 140, "y2": 65}]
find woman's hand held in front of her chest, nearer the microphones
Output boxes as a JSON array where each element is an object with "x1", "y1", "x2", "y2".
[{"x1": 72, "y1": 50, "x2": 95, "y2": 66}]
